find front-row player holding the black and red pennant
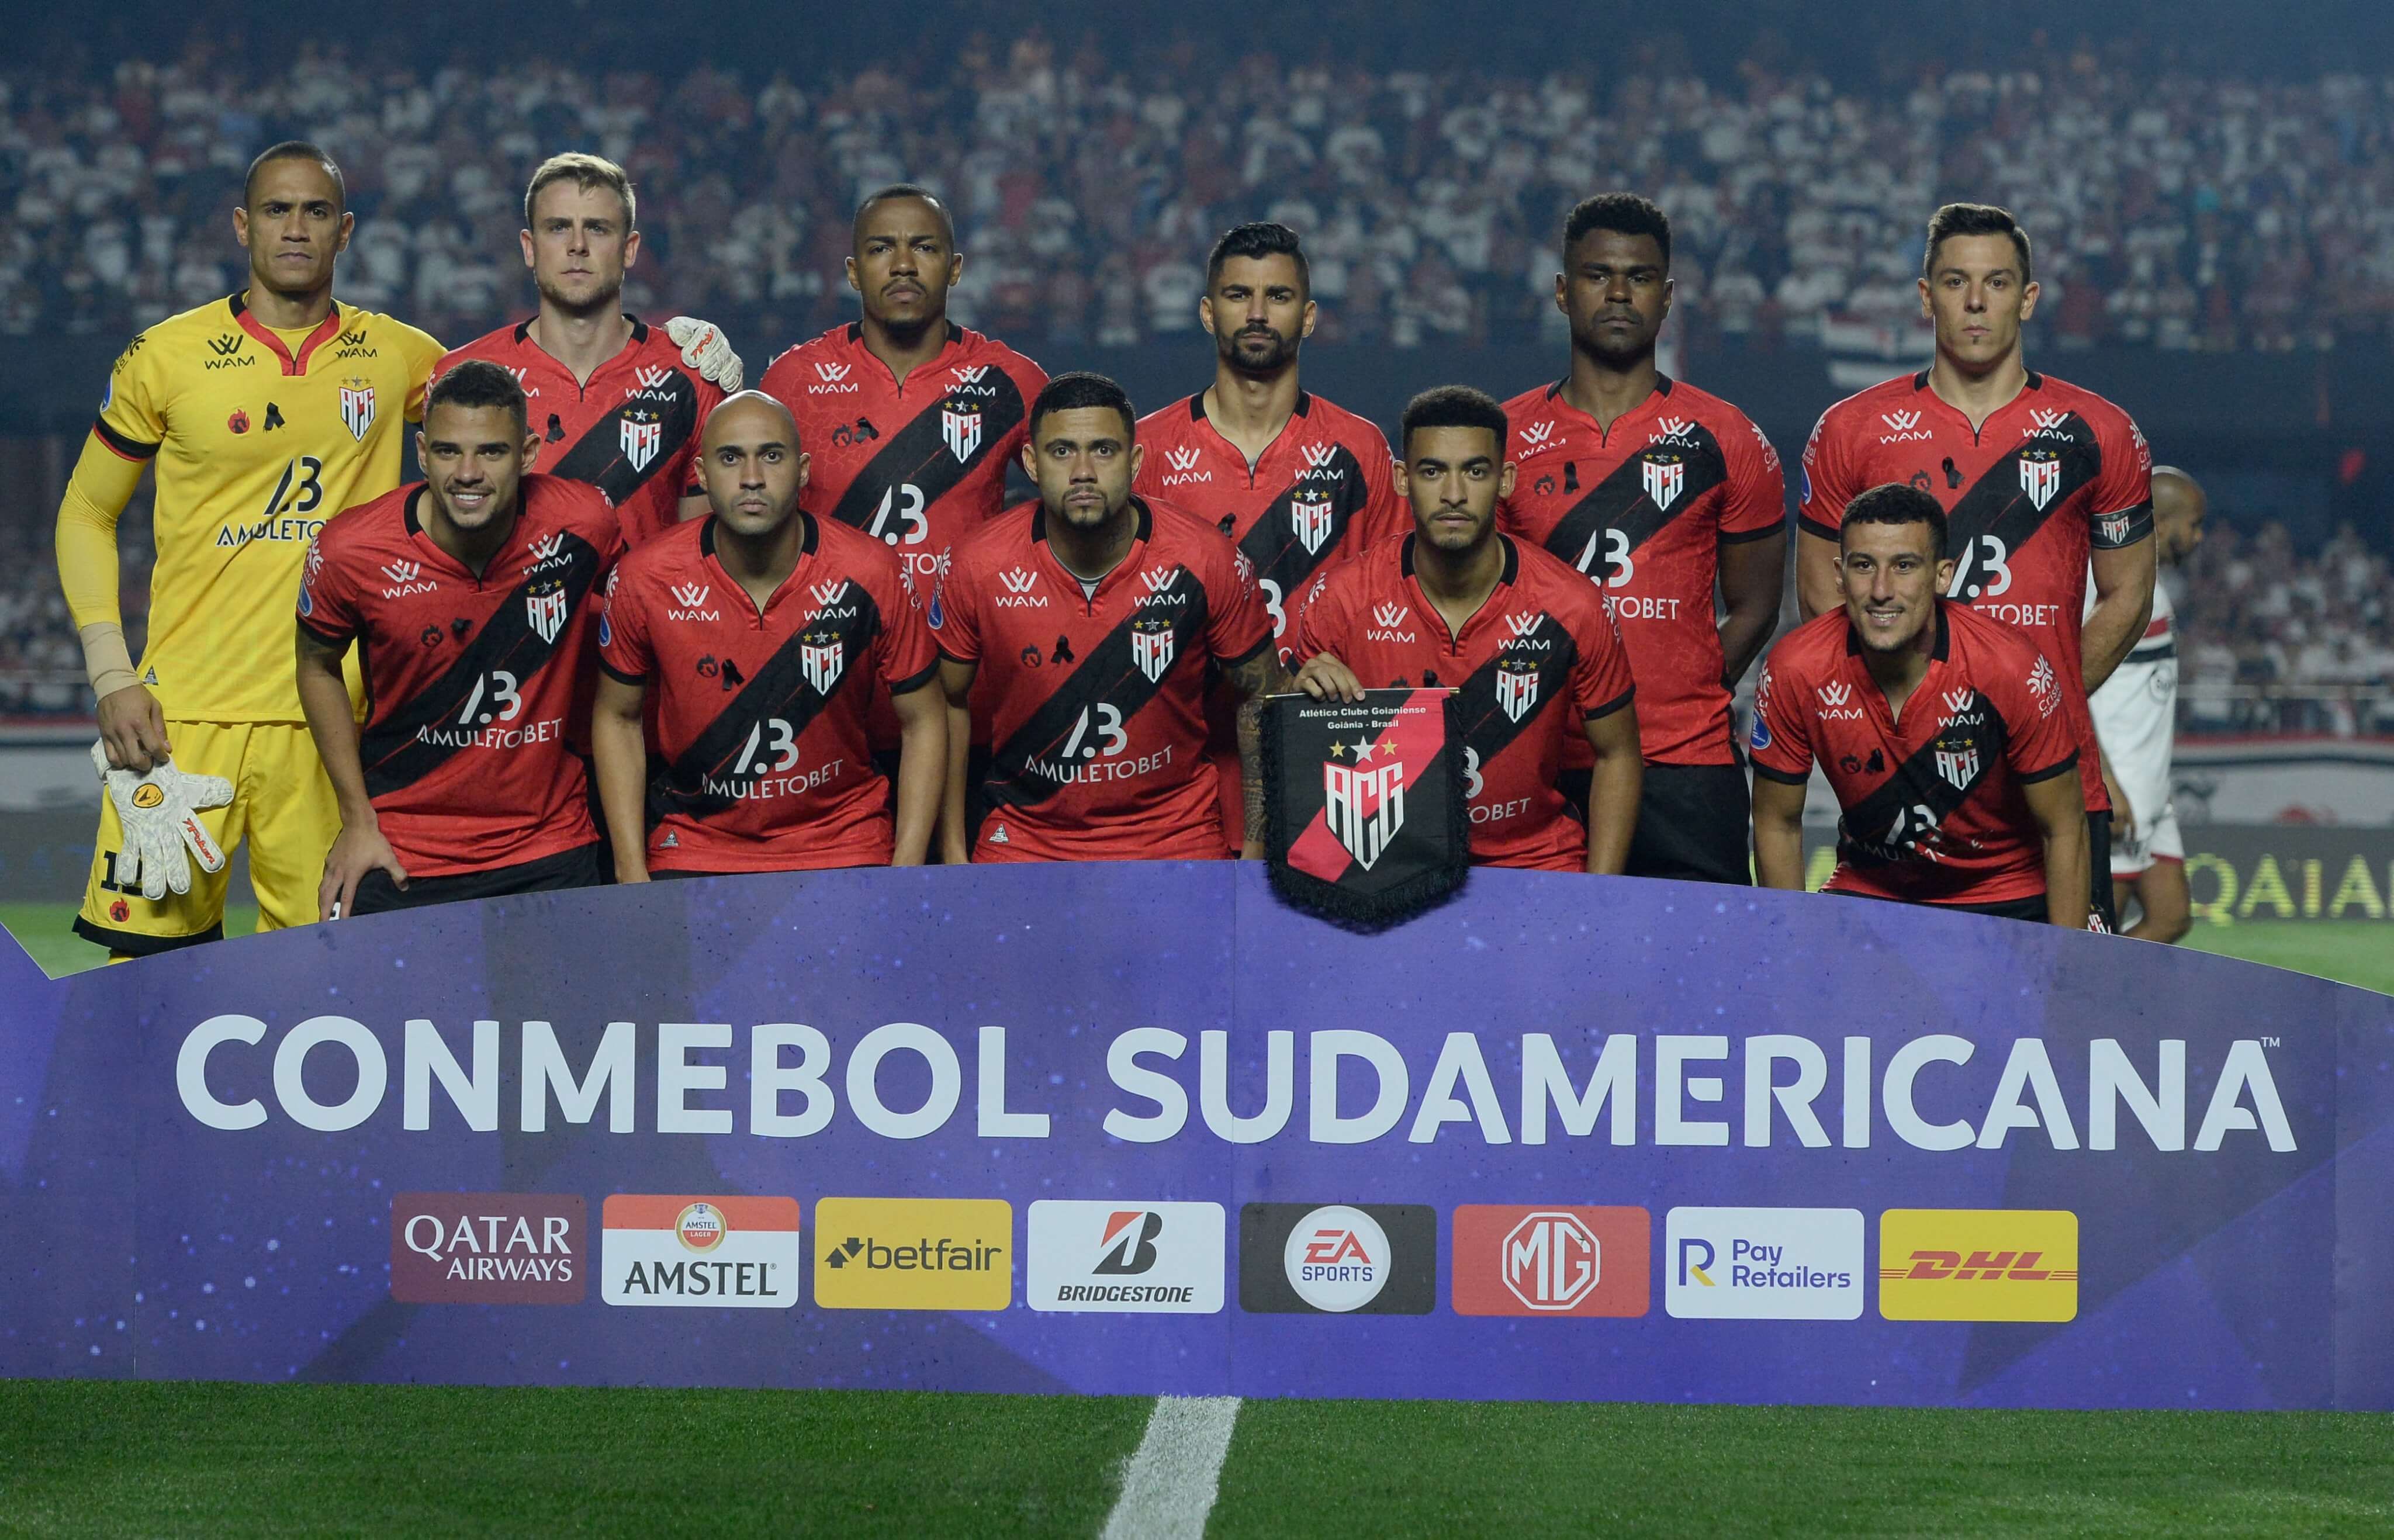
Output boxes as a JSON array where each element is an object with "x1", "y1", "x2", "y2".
[{"x1": 1295, "y1": 386, "x2": 1642, "y2": 872}]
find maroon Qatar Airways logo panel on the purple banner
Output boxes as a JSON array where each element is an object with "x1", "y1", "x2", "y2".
[{"x1": 390, "y1": 1193, "x2": 589, "y2": 1305}]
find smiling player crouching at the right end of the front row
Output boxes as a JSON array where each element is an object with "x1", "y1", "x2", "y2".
[{"x1": 1750, "y1": 484, "x2": 2088, "y2": 929}]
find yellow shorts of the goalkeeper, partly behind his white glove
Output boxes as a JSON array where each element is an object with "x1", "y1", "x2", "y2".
[{"x1": 74, "y1": 721, "x2": 340, "y2": 958}]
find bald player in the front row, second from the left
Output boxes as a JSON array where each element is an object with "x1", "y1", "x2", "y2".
[{"x1": 591, "y1": 390, "x2": 948, "y2": 881}]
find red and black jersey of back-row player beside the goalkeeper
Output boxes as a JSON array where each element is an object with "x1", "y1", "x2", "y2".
[{"x1": 433, "y1": 321, "x2": 723, "y2": 546}]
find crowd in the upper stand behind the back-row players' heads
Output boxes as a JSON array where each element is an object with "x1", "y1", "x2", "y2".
[{"x1": 0, "y1": 31, "x2": 2394, "y2": 347}]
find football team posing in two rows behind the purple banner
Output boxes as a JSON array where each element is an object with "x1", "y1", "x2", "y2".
[{"x1": 57, "y1": 141, "x2": 2205, "y2": 956}]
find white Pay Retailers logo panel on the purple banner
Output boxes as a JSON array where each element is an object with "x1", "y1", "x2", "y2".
[{"x1": 1662, "y1": 1207, "x2": 1863, "y2": 1320}]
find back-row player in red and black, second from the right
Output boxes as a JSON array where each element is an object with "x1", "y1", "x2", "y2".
[{"x1": 1499, "y1": 192, "x2": 1786, "y2": 884}]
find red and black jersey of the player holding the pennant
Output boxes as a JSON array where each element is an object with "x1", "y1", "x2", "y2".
[{"x1": 1295, "y1": 534, "x2": 1642, "y2": 872}]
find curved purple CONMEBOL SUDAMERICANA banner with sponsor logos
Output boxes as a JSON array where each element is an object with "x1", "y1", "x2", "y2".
[{"x1": 0, "y1": 862, "x2": 2394, "y2": 1409}]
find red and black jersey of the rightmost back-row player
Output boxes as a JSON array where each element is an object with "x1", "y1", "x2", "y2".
[{"x1": 1796, "y1": 369, "x2": 2152, "y2": 812}]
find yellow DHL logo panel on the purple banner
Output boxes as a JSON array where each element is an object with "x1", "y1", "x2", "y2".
[{"x1": 1879, "y1": 1209, "x2": 2078, "y2": 1320}]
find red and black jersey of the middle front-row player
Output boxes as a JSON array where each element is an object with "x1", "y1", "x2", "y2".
[{"x1": 929, "y1": 498, "x2": 1271, "y2": 860}]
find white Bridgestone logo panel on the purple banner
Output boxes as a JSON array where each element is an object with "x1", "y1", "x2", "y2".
[{"x1": 1022, "y1": 1200, "x2": 1228, "y2": 1315}]
